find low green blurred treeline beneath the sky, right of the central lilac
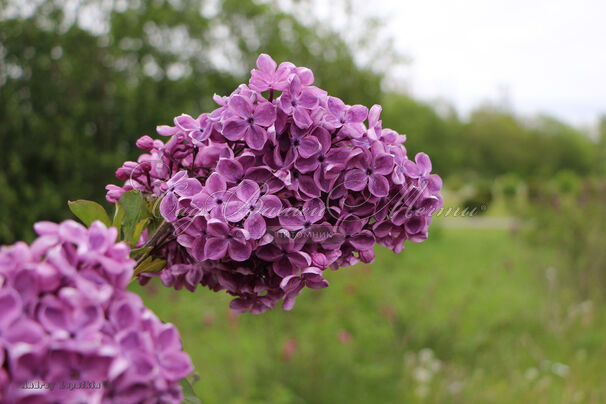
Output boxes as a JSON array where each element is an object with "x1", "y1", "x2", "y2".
[{"x1": 383, "y1": 93, "x2": 606, "y2": 180}]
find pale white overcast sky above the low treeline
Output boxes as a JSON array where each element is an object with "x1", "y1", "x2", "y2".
[{"x1": 380, "y1": 0, "x2": 606, "y2": 124}]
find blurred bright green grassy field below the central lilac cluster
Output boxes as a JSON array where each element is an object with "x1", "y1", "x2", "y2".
[{"x1": 132, "y1": 228, "x2": 606, "y2": 404}]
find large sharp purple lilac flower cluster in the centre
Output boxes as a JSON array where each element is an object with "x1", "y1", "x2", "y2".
[{"x1": 107, "y1": 54, "x2": 442, "y2": 313}]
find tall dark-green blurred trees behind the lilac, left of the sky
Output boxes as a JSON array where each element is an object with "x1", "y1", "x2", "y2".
[{"x1": 0, "y1": 0, "x2": 382, "y2": 243}]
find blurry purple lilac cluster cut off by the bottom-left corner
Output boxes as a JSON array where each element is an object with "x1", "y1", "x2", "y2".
[{"x1": 0, "y1": 221, "x2": 193, "y2": 403}]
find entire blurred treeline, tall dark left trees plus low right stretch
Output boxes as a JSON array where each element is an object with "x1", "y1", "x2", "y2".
[{"x1": 0, "y1": 0, "x2": 599, "y2": 243}]
